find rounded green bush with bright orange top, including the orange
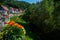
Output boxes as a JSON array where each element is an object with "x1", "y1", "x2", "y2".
[{"x1": 2, "y1": 21, "x2": 26, "y2": 40}]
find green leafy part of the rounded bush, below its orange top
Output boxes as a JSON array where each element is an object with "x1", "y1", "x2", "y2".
[{"x1": 1, "y1": 25, "x2": 25, "y2": 40}]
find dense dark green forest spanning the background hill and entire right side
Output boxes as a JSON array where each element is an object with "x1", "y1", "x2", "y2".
[{"x1": 0, "y1": 0, "x2": 60, "y2": 40}]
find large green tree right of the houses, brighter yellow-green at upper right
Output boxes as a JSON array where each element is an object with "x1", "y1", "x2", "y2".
[{"x1": 21, "y1": 0, "x2": 55, "y2": 33}]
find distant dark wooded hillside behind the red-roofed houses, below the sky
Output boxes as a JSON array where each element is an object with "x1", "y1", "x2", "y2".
[{"x1": 3, "y1": 1, "x2": 30, "y2": 9}]
